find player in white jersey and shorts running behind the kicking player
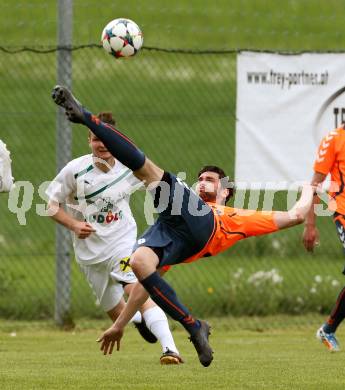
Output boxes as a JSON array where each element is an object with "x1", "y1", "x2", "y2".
[{"x1": 47, "y1": 113, "x2": 183, "y2": 364}]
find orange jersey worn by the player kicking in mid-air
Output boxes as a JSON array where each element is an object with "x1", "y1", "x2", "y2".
[{"x1": 184, "y1": 203, "x2": 278, "y2": 263}]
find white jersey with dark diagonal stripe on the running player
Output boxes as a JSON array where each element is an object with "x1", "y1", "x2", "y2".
[{"x1": 46, "y1": 154, "x2": 142, "y2": 264}]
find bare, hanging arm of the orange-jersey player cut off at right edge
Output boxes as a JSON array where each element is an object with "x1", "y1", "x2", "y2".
[{"x1": 302, "y1": 172, "x2": 327, "y2": 252}]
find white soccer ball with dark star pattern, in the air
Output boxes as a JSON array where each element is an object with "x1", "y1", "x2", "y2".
[{"x1": 101, "y1": 18, "x2": 144, "y2": 58}]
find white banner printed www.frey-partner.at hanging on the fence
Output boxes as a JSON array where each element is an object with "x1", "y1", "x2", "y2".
[{"x1": 235, "y1": 52, "x2": 345, "y2": 189}]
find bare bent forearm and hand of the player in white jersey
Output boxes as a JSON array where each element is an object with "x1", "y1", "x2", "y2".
[{"x1": 48, "y1": 200, "x2": 96, "y2": 239}]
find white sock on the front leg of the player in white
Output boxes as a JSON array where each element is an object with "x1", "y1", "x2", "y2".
[{"x1": 143, "y1": 306, "x2": 179, "y2": 354}]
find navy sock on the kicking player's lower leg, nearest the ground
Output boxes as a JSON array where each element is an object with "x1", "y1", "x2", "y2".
[{"x1": 140, "y1": 272, "x2": 200, "y2": 335}]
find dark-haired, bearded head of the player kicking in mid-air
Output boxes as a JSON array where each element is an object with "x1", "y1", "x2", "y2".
[{"x1": 196, "y1": 172, "x2": 227, "y2": 203}]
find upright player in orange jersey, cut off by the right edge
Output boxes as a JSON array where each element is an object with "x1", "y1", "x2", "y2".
[{"x1": 303, "y1": 125, "x2": 345, "y2": 352}]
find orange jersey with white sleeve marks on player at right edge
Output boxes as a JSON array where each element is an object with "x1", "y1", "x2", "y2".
[{"x1": 314, "y1": 127, "x2": 345, "y2": 214}]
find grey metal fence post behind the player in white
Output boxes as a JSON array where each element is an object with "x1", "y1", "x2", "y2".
[{"x1": 54, "y1": 0, "x2": 73, "y2": 326}]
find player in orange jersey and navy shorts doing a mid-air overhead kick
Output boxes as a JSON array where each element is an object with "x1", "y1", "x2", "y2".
[{"x1": 52, "y1": 86, "x2": 313, "y2": 367}]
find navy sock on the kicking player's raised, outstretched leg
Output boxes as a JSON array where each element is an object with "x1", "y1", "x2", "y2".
[{"x1": 83, "y1": 109, "x2": 145, "y2": 171}]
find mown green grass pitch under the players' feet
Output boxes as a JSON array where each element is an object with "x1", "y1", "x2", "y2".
[{"x1": 0, "y1": 317, "x2": 345, "y2": 390}]
